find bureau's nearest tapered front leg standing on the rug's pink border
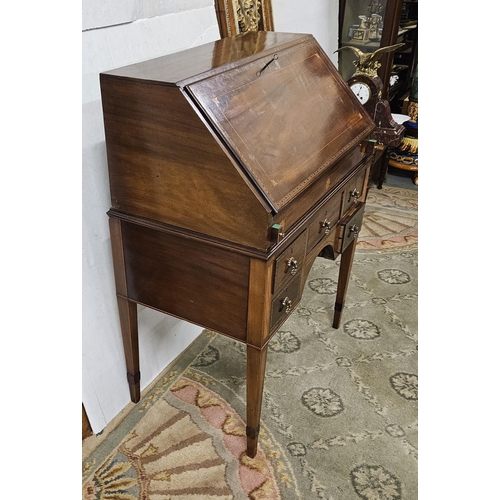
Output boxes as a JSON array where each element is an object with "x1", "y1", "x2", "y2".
[{"x1": 247, "y1": 345, "x2": 267, "y2": 458}]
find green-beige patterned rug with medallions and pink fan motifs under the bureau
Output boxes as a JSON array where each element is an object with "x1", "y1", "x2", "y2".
[{"x1": 82, "y1": 187, "x2": 418, "y2": 500}]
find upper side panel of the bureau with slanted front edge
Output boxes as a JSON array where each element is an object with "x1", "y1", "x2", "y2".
[{"x1": 101, "y1": 75, "x2": 269, "y2": 249}]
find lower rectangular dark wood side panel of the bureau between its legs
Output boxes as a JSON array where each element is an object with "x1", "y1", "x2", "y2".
[{"x1": 122, "y1": 222, "x2": 250, "y2": 340}]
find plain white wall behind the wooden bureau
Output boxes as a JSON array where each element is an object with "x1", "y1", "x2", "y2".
[{"x1": 82, "y1": 0, "x2": 338, "y2": 433}]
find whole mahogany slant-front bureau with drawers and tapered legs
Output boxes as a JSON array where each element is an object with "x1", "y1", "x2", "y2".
[{"x1": 100, "y1": 32, "x2": 375, "y2": 457}]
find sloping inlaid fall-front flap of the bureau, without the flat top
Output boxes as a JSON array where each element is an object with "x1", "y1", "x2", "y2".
[{"x1": 187, "y1": 36, "x2": 374, "y2": 211}]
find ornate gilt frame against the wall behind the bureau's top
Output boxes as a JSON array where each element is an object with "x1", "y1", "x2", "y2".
[{"x1": 215, "y1": 0, "x2": 274, "y2": 38}]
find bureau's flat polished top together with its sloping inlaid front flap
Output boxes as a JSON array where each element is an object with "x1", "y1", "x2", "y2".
[{"x1": 102, "y1": 32, "x2": 374, "y2": 212}]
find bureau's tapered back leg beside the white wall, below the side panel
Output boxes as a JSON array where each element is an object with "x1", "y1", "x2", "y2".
[{"x1": 117, "y1": 295, "x2": 141, "y2": 403}]
